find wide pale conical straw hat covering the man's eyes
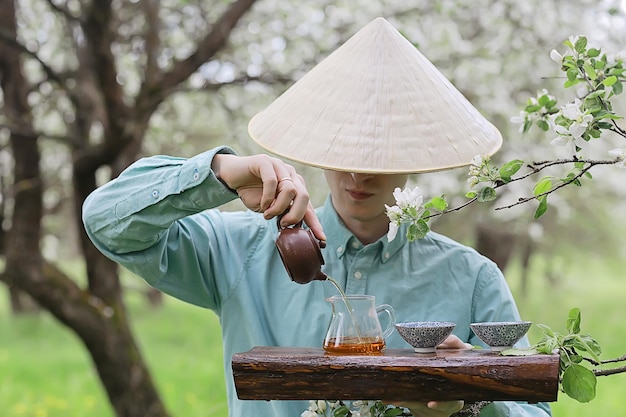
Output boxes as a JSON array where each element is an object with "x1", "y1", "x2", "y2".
[{"x1": 248, "y1": 18, "x2": 502, "y2": 174}]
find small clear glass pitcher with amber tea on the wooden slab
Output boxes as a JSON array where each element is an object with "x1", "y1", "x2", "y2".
[{"x1": 324, "y1": 295, "x2": 396, "y2": 354}]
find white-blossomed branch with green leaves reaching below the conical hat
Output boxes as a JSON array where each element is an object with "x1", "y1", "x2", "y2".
[{"x1": 386, "y1": 36, "x2": 626, "y2": 241}]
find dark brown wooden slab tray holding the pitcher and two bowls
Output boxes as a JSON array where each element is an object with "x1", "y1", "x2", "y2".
[{"x1": 232, "y1": 347, "x2": 559, "y2": 402}]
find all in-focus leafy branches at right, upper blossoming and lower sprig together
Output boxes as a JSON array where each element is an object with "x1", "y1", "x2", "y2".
[{"x1": 387, "y1": 36, "x2": 626, "y2": 402}]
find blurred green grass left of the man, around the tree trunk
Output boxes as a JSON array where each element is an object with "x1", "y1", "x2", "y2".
[{"x1": 0, "y1": 287, "x2": 228, "y2": 417}]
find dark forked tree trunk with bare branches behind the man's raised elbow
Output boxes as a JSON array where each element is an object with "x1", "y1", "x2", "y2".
[{"x1": 0, "y1": 0, "x2": 255, "y2": 417}]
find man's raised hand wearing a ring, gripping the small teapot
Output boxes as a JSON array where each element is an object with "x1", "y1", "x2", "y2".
[{"x1": 211, "y1": 154, "x2": 326, "y2": 240}]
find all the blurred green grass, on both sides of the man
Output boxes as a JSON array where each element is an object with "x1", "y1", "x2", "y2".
[{"x1": 0, "y1": 250, "x2": 626, "y2": 417}]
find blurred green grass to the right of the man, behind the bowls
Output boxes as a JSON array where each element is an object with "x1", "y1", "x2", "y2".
[{"x1": 507, "y1": 250, "x2": 626, "y2": 417}]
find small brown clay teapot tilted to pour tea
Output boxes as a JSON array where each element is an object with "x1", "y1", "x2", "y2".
[{"x1": 276, "y1": 216, "x2": 328, "y2": 284}]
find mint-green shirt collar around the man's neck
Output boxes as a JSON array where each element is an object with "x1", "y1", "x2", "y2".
[{"x1": 318, "y1": 195, "x2": 407, "y2": 263}]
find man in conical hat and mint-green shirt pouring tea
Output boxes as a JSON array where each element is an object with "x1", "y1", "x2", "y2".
[{"x1": 83, "y1": 19, "x2": 550, "y2": 417}]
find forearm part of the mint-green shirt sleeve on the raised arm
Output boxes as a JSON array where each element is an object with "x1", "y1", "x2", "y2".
[{"x1": 82, "y1": 147, "x2": 237, "y2": 253}]
